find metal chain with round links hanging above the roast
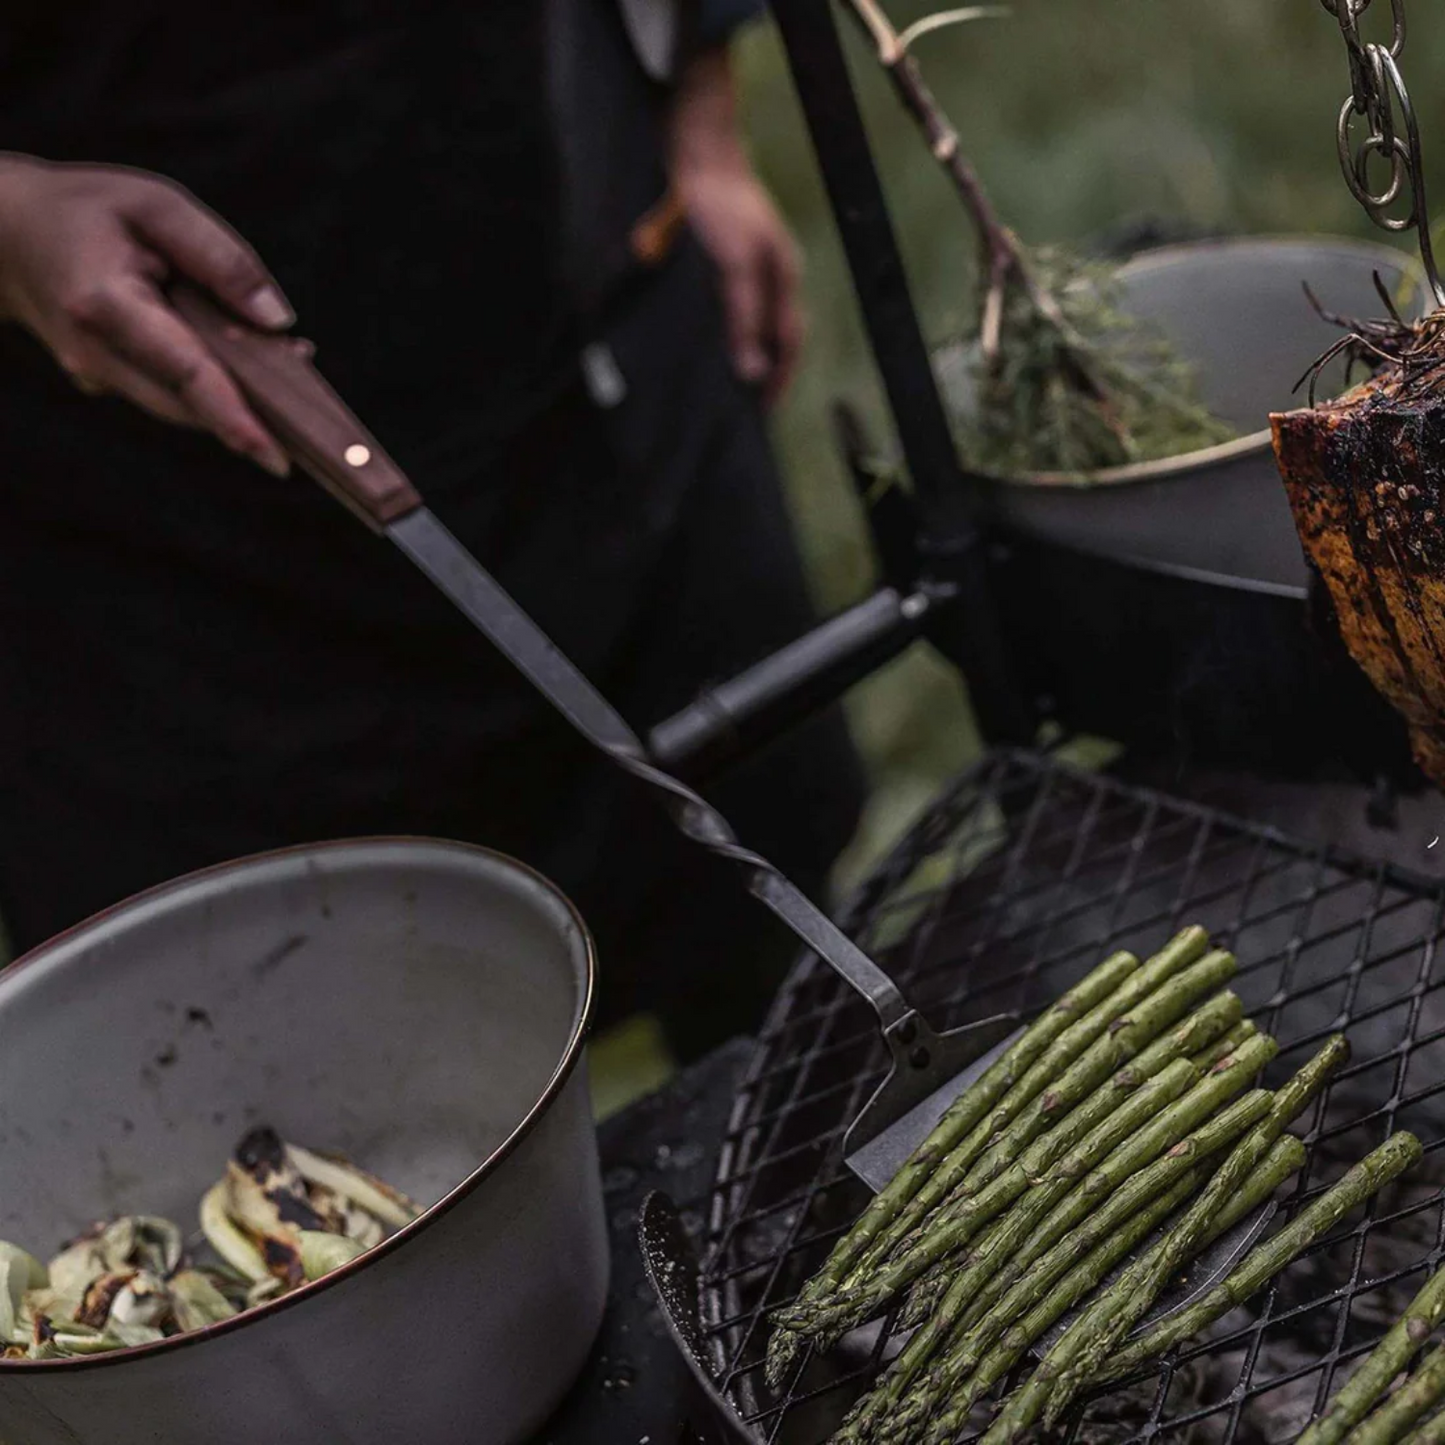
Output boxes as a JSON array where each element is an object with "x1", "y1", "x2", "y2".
[{"x1": 1319, "y1": 0, "x2": 1445, "y2": 306}]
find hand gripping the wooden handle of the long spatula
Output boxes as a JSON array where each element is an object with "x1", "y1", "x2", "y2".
[{"x1": 0, "y1": 156, "x2": 295, "y2": 475}]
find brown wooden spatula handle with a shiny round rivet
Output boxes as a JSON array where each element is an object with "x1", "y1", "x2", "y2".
[{"x1": 171, "y1": 282, "x2": 422, "y2": 532}]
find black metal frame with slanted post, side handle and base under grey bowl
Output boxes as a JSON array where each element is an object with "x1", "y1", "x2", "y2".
[{"x1": 649, "y1": 0, "x2": 1419, "y2": 811}]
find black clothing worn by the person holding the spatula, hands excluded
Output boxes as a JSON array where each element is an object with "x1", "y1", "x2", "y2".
[{"x1": 0, "y1": 0, "x2": 858, "y2": 1049}]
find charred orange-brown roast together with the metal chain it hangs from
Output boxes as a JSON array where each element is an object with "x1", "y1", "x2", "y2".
[{"x1": 1272, "y1": 0, "x2": 1445, "y2": 788}]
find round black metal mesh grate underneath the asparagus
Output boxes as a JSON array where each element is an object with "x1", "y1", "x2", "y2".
[{"x1": 701, "y1": 753, "x2": 1445, "y2": 1445}]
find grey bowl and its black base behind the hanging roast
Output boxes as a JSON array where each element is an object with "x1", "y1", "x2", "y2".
[{"x1": 941, "y1": 237, "x2": 1413, "y2": 779}]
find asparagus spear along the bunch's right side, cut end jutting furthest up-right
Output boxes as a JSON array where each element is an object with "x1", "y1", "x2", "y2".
[{"x1": 990, "y1": 1035, "x2": 1348, "y2": 1445}]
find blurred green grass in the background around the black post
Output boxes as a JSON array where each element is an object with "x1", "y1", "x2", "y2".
[{"x1": 737, "y1": 0, "x2": 1445, "y2": 883}]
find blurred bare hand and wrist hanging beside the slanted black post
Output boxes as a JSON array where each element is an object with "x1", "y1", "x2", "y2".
[{"x1": 672, "y1": 51, "x2": 803, "y2": 405}]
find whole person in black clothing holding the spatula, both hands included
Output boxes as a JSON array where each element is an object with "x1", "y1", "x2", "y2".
[{"x1": 0, "y1": 0, "x2": 861, "y2": 1056}]
